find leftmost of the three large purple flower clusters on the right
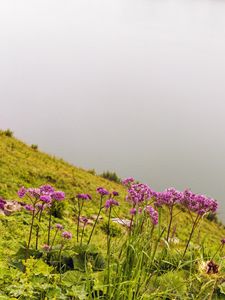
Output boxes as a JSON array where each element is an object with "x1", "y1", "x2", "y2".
[{"x1": 126, "y1": 183, "x2": 156, "y2": 205}]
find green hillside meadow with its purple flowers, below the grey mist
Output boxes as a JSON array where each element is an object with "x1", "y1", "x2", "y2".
[{"x1": 0, "y1": 131, "x2": 225, "y2": 300}]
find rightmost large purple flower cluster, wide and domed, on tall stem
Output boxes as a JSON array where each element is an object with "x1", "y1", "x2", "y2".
[{"x1": 181, "y1": 190, "x2": 218, "y2": 215}]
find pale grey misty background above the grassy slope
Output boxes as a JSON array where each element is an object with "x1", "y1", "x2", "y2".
[{"x1": 0, "y1": 0, "x2": 225, "y2": 220}]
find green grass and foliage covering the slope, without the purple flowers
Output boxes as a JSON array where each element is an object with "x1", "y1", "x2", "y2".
[{"x1": 0, "y1": 131, "x2": 225, "y2": 300}]
